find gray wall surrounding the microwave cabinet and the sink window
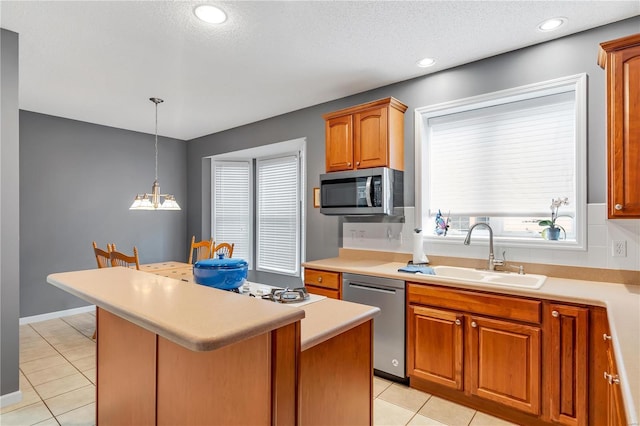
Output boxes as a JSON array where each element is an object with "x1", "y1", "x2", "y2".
[{"x1": 187, "y1": 17, "x2": 640, "y2": 260}]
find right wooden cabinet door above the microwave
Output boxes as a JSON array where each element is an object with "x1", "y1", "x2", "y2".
[{"x1": 354, "y1": 107, "x2": 389, "y2": 169}]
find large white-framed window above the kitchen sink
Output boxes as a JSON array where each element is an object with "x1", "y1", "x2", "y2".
[{"x1": 416, "y1": 74, "x2": 586, "y2": 247}]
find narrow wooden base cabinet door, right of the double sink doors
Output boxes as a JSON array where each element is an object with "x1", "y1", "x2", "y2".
[{"x1": 545, "y1": 304, "x2": 589, "y2": 425}]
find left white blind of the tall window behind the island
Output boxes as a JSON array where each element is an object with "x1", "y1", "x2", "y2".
[{"x1": 212, "y1": 161, "x2": 251, "y2": 262}]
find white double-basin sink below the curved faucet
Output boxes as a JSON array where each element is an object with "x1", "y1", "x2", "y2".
[{"x1": 433, "y1": 266, "x2": 547, "y2": 289}]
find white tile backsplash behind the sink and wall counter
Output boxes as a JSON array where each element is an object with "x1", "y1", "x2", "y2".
[{"x1": 342, "y1": 204, "x2": 640, "y2": 271}]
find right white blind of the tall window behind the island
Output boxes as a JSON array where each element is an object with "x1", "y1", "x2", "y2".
[{"x1": 256, "y1": 155, "x2": 300, "y2": 275}]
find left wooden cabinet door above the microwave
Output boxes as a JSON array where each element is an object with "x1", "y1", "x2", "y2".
[{"x1": 325, "y1": 115, "x2": 354, "y2": 172}]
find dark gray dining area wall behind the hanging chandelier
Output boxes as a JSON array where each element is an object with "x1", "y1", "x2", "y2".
[{"x1": 19, "y1": 111, "x2": 188, "y2": 318}]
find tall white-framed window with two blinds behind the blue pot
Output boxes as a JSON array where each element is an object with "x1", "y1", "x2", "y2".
[{"x1": 211, "y1": 139, "x2": 306, "y2": 277}]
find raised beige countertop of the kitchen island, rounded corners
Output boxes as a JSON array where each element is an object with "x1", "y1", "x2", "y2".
[{"x1": 47, "y1": 267, "x2": 305, "y2": 351}]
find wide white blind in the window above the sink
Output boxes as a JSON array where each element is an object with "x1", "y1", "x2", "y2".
[{"x1": 425, "y1": 90, "x2": 576, "y2": 216}]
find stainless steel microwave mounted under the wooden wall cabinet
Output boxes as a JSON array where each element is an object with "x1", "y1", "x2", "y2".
[{"x1": 320, "y1": 167, "x2": 404, "y2": 216}]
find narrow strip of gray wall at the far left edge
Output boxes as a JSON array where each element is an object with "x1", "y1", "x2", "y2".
[{"x1": 0, "y1": 29, "x2": 20, "y2": 395}]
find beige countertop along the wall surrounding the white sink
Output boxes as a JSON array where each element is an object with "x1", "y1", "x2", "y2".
[{"x1": 303, "y1": 257, "x2": 640, "y2": 426}]
